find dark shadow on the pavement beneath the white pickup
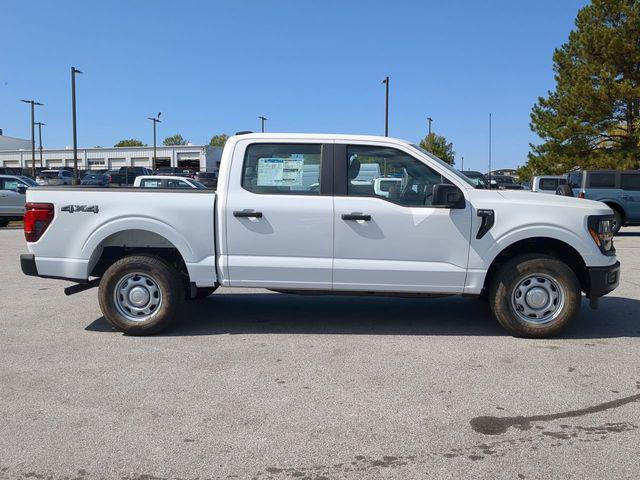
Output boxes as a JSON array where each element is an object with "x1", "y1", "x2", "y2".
[{"x1": 86, "y1": 292, "x2": 640, "y2": 339}]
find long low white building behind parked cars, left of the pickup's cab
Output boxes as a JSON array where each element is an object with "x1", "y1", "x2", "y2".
[{"x1": 0, "y1": 143, "x2": 222, "y2": 172}]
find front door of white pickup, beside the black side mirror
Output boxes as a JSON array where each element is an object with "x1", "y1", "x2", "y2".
[{"x1": 333, "y1": 145, "x2": 471, "y2": 293}]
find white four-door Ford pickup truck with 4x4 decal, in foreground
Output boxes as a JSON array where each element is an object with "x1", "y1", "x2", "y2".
[{"x1": 21, "y1": 134, "x2": 620, "y2": 337}]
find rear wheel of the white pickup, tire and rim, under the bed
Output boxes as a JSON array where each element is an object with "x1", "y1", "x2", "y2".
[{"x1": 98, "y1": 255, "x2": 185, "y2": 335}]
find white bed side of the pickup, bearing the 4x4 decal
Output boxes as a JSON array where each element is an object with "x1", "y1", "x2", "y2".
[{"x1": 27, "y1": 186, "x2": 216, "y2": 286}]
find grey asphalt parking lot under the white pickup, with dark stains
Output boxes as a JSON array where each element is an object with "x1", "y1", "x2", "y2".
[{"x1": 0, "y1": 228, "x2": 640, "y2": 480}]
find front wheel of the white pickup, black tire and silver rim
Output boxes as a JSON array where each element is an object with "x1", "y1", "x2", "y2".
[{"x1": 489, "y1": 254, "x2": 582, "y2": 338}]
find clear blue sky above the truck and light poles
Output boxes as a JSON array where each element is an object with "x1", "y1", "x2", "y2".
[{"x1": 0, "y1": 0, "x2": 586, "y2": 171}]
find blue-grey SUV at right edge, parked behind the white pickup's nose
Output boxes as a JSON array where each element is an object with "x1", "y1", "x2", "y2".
[{"x1": 567, "y1": 170, "x2": 640, "y2": 233}]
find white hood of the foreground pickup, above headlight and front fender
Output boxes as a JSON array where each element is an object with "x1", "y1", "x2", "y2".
[{"x1": 473, "y1": 190, "x2": 611, "y2": 215}]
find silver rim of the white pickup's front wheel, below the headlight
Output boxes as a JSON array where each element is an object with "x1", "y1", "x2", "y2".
[{"x1": 511, "y1": 274, "x2": 565, "y2": 325}]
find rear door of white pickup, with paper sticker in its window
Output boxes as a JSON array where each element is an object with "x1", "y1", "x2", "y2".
[{"x1": 221, "y1": 140, "x2": 333, "y2": 290}]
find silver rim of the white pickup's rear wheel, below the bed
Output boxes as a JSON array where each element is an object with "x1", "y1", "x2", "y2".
[{"x1": 113, "y1": 273, "x2": 162, "y2": 322}]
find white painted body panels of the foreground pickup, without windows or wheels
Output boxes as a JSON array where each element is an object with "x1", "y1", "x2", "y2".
[{"x1": 27, "y1": 134, "x2": 616, "y2": 294}]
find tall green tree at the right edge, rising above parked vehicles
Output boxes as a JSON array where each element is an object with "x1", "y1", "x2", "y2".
[{"x1": 520, "y1": 0, "x2": 640, "y2": 178}]
